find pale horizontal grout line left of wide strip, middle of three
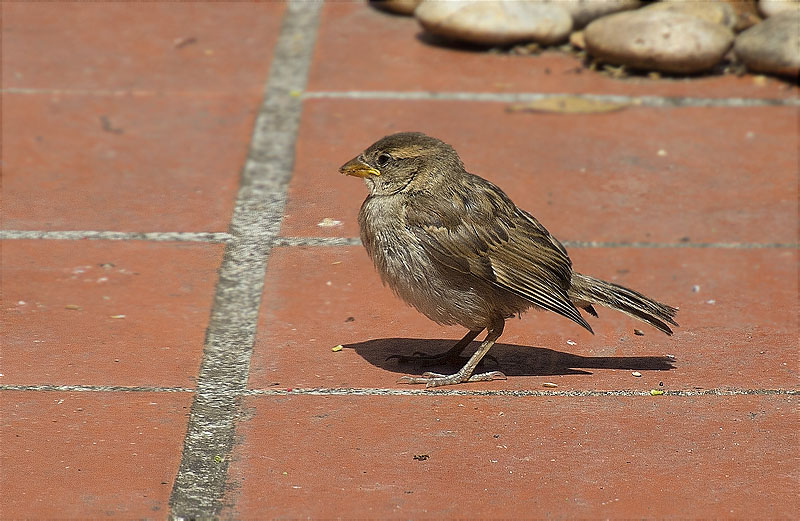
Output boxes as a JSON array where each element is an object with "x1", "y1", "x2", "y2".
[{"x1": 0, "y1": 230, "x2": 233, "y2": 242}]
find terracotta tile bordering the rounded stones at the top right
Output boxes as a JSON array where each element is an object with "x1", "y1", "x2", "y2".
[{"x1": 308, "y1": 2, "x2": 798, "y2": 98}]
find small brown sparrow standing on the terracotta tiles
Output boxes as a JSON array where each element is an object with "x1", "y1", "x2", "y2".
[{"x1": 339, "y1": 132, "x2": 678, "y2": 387}]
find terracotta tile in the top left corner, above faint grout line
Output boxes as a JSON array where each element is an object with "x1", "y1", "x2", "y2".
[{"x1": 3, "y1": 2, "x2": 285, "y2": 90}]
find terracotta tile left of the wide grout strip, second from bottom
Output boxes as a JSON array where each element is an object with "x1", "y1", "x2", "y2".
[{"x1": 0, "y1": 240, "x2": 224, "y2": 386}]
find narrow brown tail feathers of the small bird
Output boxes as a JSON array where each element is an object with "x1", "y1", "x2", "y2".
[{"x1": 569, "y1": 272, "x2": 678, "y2": 335}]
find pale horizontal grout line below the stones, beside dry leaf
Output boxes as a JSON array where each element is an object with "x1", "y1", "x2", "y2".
[{"x1": 302, "y1": 90, "x2": 800, "y2": 107}]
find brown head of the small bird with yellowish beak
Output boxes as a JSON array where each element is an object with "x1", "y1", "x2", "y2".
[{"x1": 339, "y1": 132, "x2": 464, "y2": 195}]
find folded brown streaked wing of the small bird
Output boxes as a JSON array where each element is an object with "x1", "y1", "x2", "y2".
[{"x1": 406, "y1": 175, "x2": 592, "y2": 331}]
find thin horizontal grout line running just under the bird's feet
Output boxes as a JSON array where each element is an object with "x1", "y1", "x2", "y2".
[{"x1": 0, "y1": 384, "x2": 800, "y2": 397}]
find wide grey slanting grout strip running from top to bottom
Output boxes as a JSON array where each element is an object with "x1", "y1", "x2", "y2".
[{"x1": 169, "y1": 0, "x2": 321, "y2": 520}]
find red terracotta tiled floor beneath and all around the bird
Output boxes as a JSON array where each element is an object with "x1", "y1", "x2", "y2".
[{"x1": 0, "y1": 2, "x2": 800, "y2": 521}]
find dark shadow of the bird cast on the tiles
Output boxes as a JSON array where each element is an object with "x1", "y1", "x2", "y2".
[{"x1": 344, "y1": 338, "x2": 675, "y2": 376}]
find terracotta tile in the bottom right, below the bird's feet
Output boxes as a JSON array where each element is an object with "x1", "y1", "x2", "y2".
[{"x1": 226, "y1": 396, "x2": 800, "y2": 519}]
